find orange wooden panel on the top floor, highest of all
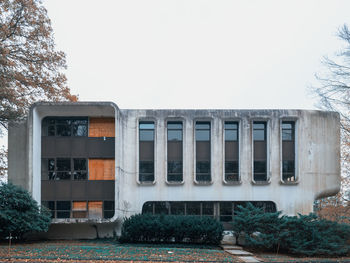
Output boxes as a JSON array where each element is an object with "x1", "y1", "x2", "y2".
[{"x1": 89, "y1": 118, "x2": 115, "y2": 137}]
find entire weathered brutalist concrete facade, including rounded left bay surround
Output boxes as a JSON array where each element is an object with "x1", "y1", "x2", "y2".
[{"x1": 9, "y1": 102, "x2": 340, "y2": 238}]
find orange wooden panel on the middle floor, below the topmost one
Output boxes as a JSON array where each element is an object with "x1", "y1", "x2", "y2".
[{"x1": 89, "y1": 159, "x2": 115, "y2": 180}]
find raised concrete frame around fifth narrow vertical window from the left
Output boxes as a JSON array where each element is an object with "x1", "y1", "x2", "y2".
[{"x1": 250, "y1": 117, "x2": 271, "y2": 185}]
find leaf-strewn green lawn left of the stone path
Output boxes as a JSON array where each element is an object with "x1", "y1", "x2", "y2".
[{"x1": 0, "y1": 240, "x2": 239, "y2": 262}]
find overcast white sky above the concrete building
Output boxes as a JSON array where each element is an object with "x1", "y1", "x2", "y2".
[{"x1": 44, "y1": 0, "x2": 350, "y2": 109}]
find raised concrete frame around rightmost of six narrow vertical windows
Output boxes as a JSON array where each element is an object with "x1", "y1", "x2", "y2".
[{"x1": 279, "y1": 116, "x2": 300, "y2": 185}]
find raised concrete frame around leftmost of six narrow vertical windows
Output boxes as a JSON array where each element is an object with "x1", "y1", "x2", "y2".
[{"x1": 135, "y1": 117, "x2": 159, "y2": 186}]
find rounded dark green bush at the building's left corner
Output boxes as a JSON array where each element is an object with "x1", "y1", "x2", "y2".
[{"x1": 0, "y1": 183, "x2": 51, "y2": 239}]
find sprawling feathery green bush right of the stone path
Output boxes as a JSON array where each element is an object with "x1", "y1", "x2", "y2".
[{"x1": 233, "y1": 203, "x2": 350, "y2": 256}]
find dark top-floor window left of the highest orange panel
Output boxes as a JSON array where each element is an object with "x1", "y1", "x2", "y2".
[{"x1": 42, "y1": 117, "x2": 88, "y2": 137}]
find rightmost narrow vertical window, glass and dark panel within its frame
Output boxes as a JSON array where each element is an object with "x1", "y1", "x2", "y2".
[{"x1": 282, "y1": 121, "x2": 296, "y2": 182}]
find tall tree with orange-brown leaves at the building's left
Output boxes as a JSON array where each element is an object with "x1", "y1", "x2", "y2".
[{"x1": 0, "y1": 0, "x2": 77, "y2": 179}]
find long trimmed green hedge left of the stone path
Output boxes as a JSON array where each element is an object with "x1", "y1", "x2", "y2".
[{"x1": 119, "y1": 214, "x2": 223, "y2": 244}]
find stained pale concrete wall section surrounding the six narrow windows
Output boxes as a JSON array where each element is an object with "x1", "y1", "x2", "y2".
[{"x1": 117, "y1": 110, "x2": 340, "y2": 217}]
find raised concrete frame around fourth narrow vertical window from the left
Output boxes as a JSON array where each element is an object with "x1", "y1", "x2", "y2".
[{"x1": 221, "y1": 118, "x2": 243, "y2": 185}]
